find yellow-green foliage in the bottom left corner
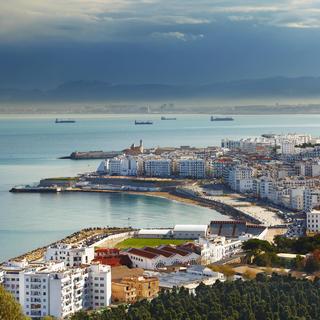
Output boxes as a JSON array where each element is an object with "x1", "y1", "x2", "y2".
[{"x1": 0, "y1": 285, "x2": 29, "y2": 320}]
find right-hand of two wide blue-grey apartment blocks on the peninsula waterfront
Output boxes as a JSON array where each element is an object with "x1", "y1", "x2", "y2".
[{"x1": 178, "y1": 159, "x2": 206, "y2": 179}]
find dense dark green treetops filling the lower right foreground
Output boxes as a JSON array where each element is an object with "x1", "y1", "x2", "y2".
[{"x1": 71, "y1": 274, "x2": 320, "y2": 320}]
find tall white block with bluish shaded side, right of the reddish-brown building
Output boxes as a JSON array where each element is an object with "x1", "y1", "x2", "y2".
[{"x1": 227, "y1": 165, "x2": 253, "y2": 193}]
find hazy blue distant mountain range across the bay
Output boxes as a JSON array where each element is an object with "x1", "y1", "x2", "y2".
[{"x1": 0, "y1": 77, "x2": 320, "y2": 102}]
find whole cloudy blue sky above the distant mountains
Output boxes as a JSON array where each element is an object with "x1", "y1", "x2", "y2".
[{"x1": 0, "y1": 0, "x2": 320, "y2": 89}]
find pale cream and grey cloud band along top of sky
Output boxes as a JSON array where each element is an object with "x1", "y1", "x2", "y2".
[{"x1": 0, "y1": 0, "x2": 320, "y2": 42}]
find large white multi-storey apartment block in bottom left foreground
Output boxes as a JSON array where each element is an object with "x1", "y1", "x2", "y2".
[{"x1": 1, "y1": 262, "x2": 111, "y2": 319}]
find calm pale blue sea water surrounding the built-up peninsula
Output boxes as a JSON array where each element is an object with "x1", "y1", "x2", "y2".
[{"x1": 0, "y1": 115, "x2": 320, "y2": 261}]
